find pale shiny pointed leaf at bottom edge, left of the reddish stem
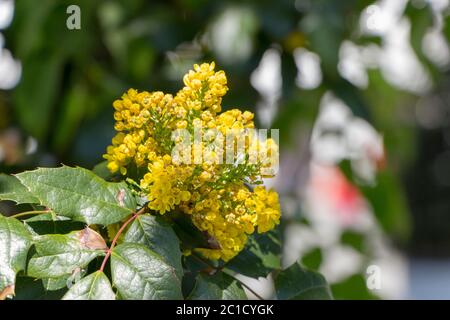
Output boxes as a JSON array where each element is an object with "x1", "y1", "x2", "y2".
[{"x1": 63, "y1": 271, "x2": 115, "y2": 300}]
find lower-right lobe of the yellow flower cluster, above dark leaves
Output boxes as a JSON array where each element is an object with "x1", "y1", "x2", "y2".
[{"x1": 183, "y1": 185, "x2": 280, "y2": 261}]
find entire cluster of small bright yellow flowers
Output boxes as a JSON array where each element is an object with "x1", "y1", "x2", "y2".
[{"x1": 104, "y1": 63, "x2": 280, "y2": 261}]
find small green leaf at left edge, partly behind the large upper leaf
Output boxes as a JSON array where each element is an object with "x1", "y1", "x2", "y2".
[{"x1": 0, "y1": 174, "x2": 39, "y2": 204}]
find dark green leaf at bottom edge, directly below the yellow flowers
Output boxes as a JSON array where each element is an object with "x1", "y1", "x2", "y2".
[{"x1": 190, "y1": 272, "x2": 247, "y2": 300}]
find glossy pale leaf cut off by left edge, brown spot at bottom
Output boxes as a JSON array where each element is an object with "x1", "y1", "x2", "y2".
[{"x1": 0, "y1": 214, "x2": 32, "y2": 299}]
